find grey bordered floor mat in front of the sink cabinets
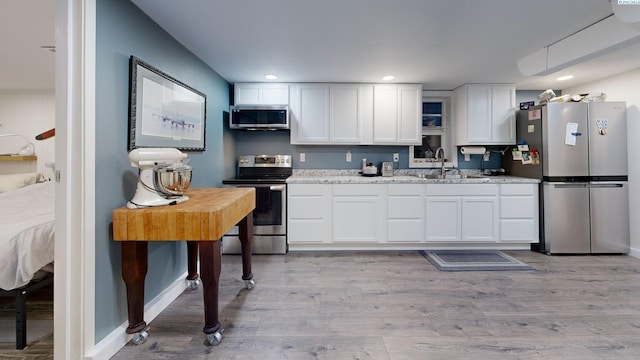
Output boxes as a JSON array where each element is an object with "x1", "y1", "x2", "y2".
[{"x1": 420, "y1": 250, "x2": 535, "y2": 271}]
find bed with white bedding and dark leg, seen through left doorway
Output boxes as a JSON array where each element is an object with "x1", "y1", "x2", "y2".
[{"x1": 0, "y1": 173, "x2": 55, "y2": 349}]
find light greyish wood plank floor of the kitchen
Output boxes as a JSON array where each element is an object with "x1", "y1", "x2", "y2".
[{"x1": 113, "y1": 251, "x2": 640, "y2": 360}]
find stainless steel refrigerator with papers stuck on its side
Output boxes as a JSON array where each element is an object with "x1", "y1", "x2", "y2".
[{"x1": 503, "y1": 102, "x2": 629, "y2": 254}]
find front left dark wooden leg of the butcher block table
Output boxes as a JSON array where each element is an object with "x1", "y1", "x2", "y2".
[{"x1": 121, "y1": 241, "x2": 148, "y2": 334}]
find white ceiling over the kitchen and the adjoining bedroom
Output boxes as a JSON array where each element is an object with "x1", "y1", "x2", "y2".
[{"x1": 0, "y1": 0, "x2": 640, "y2": 90}]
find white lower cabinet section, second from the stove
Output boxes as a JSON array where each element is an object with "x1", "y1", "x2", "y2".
[{"x1": 332, "y1": 184, "x2": 386, "y2": 243}]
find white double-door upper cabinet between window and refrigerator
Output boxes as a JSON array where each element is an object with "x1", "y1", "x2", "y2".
[{"x1": 453, "y1": 84, "x2": 516, "y2": 146}]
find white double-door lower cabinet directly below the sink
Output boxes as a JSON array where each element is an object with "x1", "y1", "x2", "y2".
[{"x1": 426, "y1": 184, "x2": 499, "y2": 243}]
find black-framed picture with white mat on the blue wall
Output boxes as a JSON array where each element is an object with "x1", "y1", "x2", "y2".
[{"x1": 129, "y1": 56, "x2": 207, "y2": 151}]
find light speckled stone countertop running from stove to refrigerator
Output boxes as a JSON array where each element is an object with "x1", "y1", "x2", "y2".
[{"x1": 287, "y1": 169, "x2": 540, "y2": 184}]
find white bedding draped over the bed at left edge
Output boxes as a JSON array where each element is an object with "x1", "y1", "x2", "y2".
[{"x1": 0, "y1": 181, "x2": 55, "y2": 290}]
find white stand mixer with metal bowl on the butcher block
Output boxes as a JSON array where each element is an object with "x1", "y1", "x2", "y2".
[{"x1": 127, "y1": 148, "x2": 191, "y2": 209}]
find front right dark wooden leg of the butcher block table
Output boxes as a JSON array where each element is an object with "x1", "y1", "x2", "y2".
[{"x1": 199, "y1": 241, "x2": 222, "y2": 334}]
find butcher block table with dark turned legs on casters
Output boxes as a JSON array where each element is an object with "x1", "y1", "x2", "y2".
[{"x1": 113, "y1": 188, "x2": 255, "y2": 345}]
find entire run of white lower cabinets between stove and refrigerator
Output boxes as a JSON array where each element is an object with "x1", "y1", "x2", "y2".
[{"x1": 287, "y1": 183, "x2": 539, "y2": 250}]
